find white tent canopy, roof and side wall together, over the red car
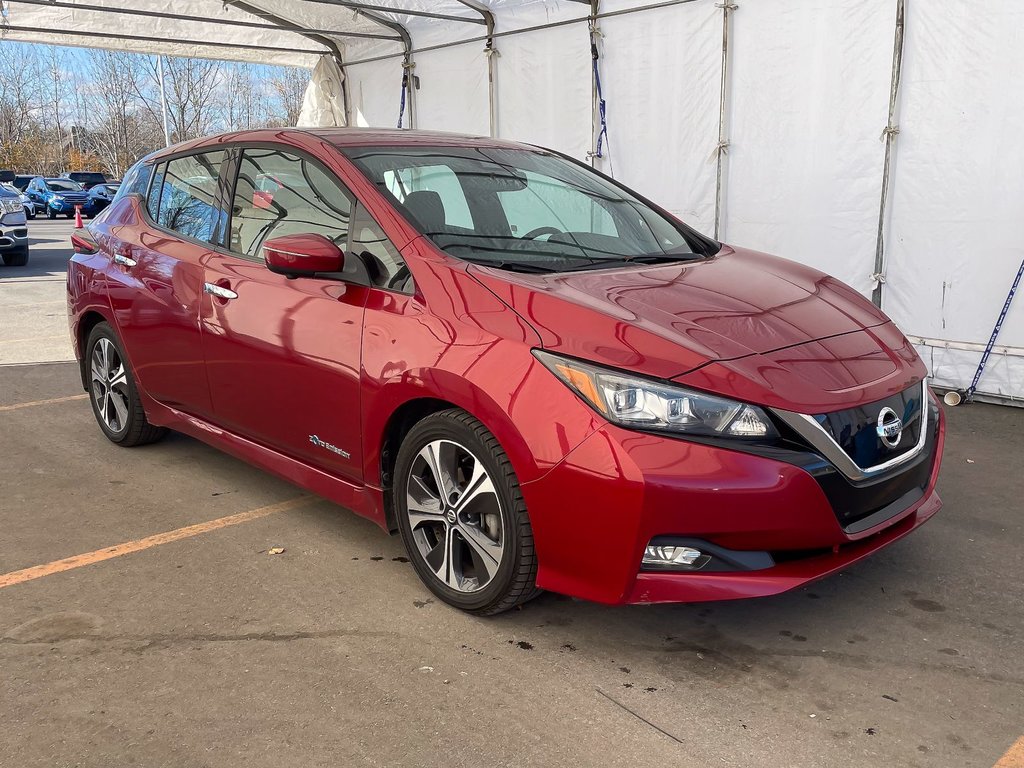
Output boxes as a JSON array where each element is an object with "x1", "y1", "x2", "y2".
[{"x1": 0, "y1": 0, "x2": 1024, "y2": 399}]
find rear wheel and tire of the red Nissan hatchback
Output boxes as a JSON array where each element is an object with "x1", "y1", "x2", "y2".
[{"x1": 83, "y1": 323, "x2": 167, "y2": 447}]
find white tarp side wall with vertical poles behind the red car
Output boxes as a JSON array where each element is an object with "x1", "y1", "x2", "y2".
[{"x1": 327, "y1": 0, "x2": 1024, "y2": 399}]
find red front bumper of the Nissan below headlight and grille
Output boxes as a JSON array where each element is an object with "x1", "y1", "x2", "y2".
[{"x1": 522, "y1": 393, "x2": 945, "y2": 603}]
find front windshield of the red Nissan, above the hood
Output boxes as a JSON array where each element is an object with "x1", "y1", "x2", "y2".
[{"x1": 346, "y1": 146, "x2": 717, "y2": 272}]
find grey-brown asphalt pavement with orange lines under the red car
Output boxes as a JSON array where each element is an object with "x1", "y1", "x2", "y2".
[{"x1": 0, "y1": 221, "x2": 1024, "y2": 768}]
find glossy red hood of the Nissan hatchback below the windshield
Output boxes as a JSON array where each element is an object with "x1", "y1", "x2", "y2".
[{"x1": 470, "y1": 247, "x2": 912, "y2": 404}]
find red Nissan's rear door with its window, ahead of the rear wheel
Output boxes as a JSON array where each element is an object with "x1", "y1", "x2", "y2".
[{"x1": 97, "y1": 151, "x2": 227, "y2": 417}]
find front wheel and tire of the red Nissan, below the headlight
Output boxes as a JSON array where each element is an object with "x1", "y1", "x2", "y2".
[{"x1": 393, "y1": 409, "x2": 537, "y2": 615}]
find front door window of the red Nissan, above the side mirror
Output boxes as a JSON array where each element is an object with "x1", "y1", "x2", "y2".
[{"x1": 230, "y1": 148, "x2": 352, "y2": 258}]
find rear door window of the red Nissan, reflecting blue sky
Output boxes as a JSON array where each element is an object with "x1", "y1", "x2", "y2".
[{"x1": 150, "y1": 151, "x2": 225, "y2": 244}]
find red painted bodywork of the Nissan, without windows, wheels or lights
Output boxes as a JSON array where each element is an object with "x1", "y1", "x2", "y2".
[{"x1": 68, "y1": 129, "x2": 943, "y2": 603}]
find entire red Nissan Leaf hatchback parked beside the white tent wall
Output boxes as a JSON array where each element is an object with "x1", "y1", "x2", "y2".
[{"x1": 68, "y1": 129, "x2": 943, "y2": 614}]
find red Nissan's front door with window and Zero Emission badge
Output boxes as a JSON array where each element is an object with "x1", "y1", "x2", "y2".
[{"x1": 202, "y1": 145, "x2": 368, "y2": 481}]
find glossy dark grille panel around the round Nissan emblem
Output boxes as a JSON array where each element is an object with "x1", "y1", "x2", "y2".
[{"x1": 814, "y1": 384, "x2": 924, "y2": 469}]
